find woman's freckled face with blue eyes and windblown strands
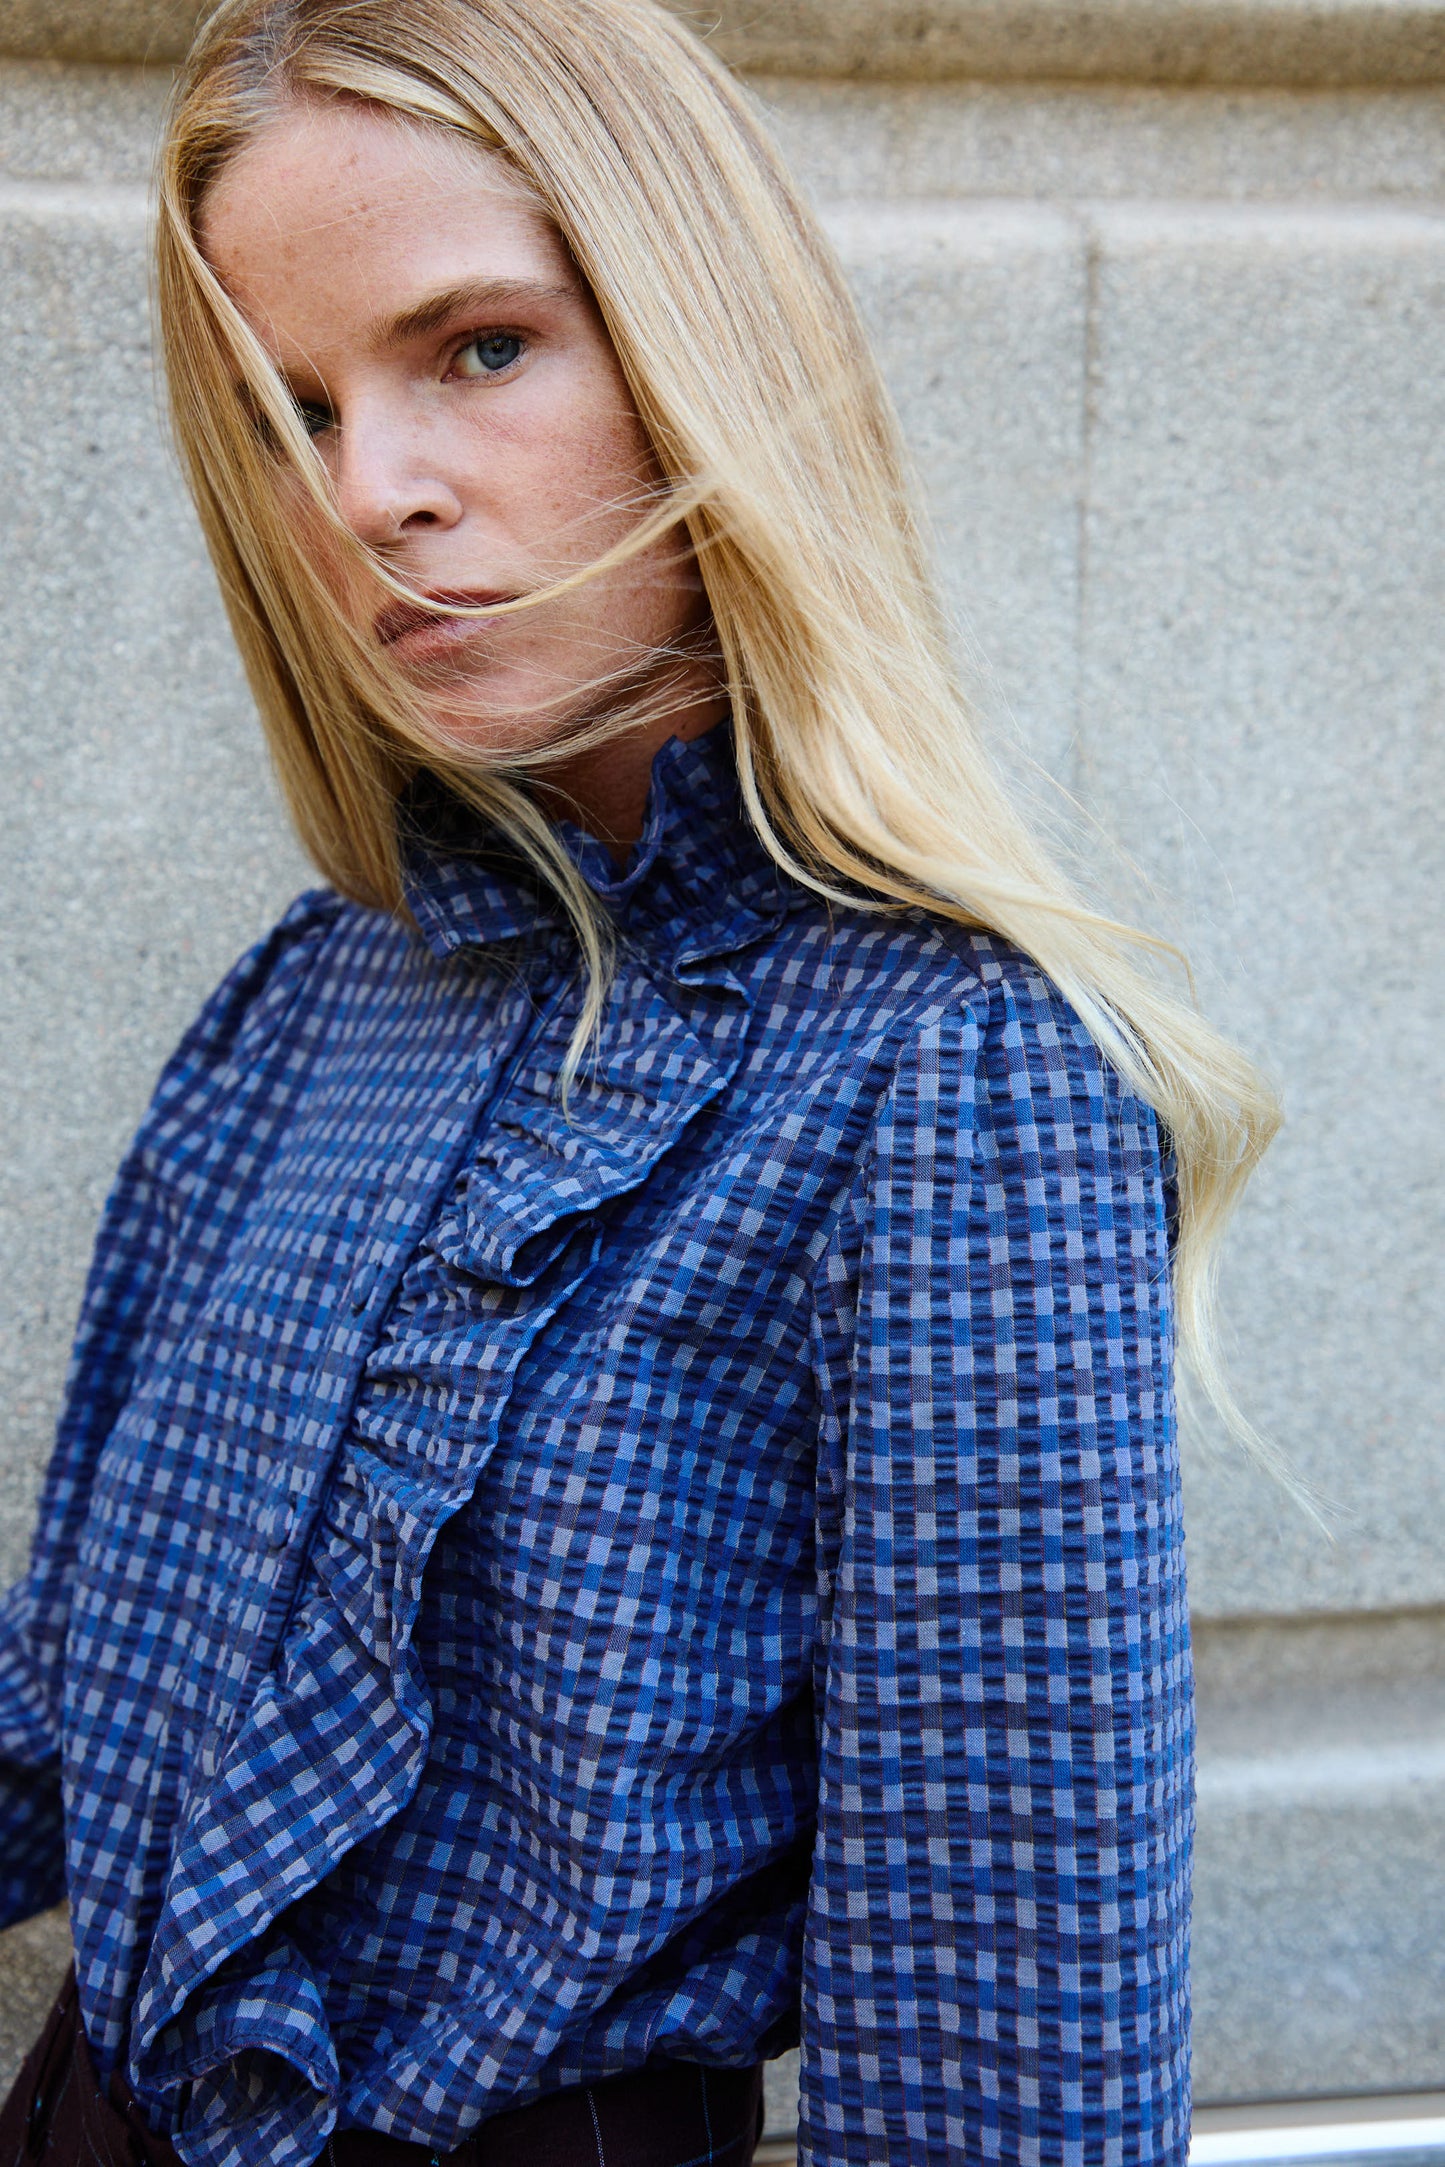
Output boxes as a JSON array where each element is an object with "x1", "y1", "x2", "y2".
[{"x1": 201, "y1": 104, "x2": 717, "y2": 832}]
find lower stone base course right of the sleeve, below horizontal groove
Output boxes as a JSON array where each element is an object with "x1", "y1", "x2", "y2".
[{"x1": 1194, "y1": 1614, "x2": 1445, "y2": 2102}]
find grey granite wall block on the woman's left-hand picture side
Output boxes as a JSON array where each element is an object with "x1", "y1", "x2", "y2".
[{"x1": 0, "y1": 186, "x2": 303, "y2": 1582}]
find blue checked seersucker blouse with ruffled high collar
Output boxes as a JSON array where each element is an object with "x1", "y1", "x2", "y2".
[{"x1": 0, "y1": 732, "x2": 1192, "y2": 2167}]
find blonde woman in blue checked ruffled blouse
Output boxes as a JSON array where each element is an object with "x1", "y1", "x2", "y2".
[{"x1": 0, "y1": 0, "x2": 1272, "y2": 2167}]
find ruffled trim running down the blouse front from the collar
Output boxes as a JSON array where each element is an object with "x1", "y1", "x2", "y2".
[{"x1": 130, "y1": 739, "x2": 789, "y2": 2167}]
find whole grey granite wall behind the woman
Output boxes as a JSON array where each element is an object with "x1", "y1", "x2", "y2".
[{"x1": 0, "y1": 0, "x2": 1445, "y2": 2132}]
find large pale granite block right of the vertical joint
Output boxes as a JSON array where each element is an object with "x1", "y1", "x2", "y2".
[{"x1": 1077, "y1": 208, "x2": 1445, "y2": 1614}]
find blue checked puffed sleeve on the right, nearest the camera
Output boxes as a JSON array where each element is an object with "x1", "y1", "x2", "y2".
[{"x1": 802, "y1": 966, "x2": 1192, "y2": 2167}]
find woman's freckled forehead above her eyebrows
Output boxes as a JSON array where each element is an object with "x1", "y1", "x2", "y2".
[{"x1": 199, "y1": 100, "x2": 576, "y2": 349}]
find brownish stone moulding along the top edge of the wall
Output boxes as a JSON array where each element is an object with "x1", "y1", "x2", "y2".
[{"x1": 0, "y1": 0, "x2": 1445, "y2": 87}]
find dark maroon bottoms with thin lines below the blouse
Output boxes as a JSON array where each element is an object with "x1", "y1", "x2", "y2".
[{"x1": 0, "y1": 1974, "x2": 763, "y2": 2167}]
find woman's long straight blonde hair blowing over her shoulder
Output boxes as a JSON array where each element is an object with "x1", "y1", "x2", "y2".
[{"x1": 158, "y1": 0, "x2": 1278, "y2": 1456}]
